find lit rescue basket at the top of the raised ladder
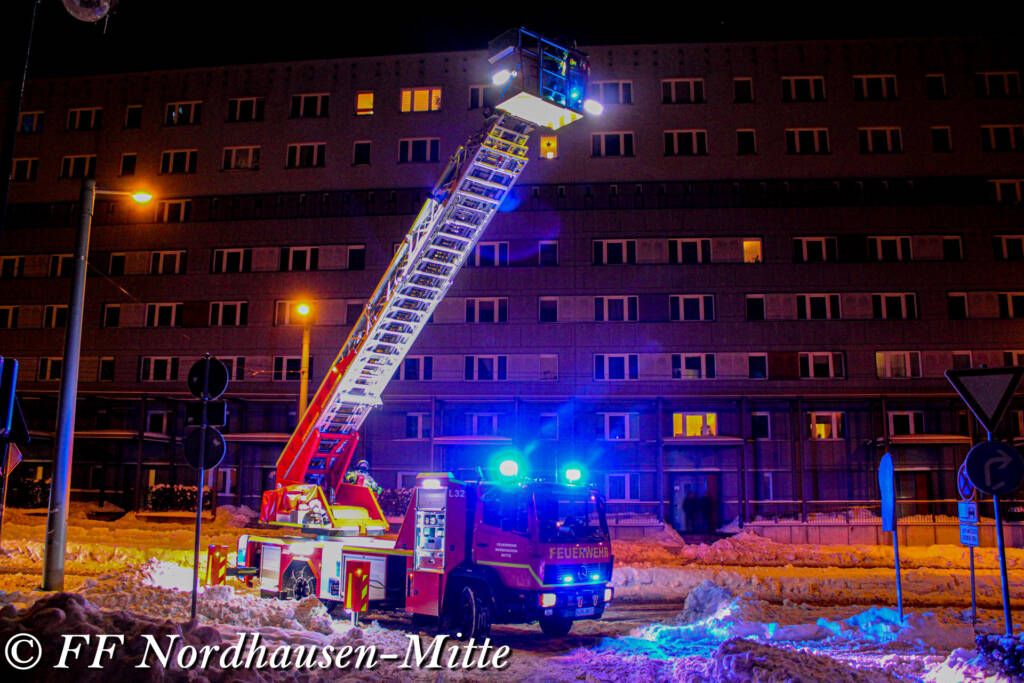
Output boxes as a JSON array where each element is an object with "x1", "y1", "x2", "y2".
[{"x1": 487, "y1": 29, "x2": 590, "y2": 130}]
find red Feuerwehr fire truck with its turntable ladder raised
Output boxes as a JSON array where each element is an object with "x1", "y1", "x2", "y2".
[{"x1": 233, "y1": 28, "x2": 612, "y2": 638}]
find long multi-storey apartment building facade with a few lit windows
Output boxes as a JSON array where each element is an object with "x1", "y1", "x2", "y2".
[{"x1": 0, "y1": 39, "x2": 1024, "y2": 528}]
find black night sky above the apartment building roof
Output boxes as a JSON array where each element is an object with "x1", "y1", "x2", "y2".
[{"x1": 0, "y1": 0, "x2": 1024, "y2": 80}]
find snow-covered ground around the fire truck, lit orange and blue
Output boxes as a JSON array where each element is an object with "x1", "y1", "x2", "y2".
[{"x1": 0, "y1": 505, "x2": 1011, "y2": 683}]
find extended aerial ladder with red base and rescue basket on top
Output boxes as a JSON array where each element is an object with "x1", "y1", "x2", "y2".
[{"x1": 260, "y1": 29, "x2": 593, "y2": 535}]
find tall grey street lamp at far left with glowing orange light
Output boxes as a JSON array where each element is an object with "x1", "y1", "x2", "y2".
[{"x1": 43, "y1": 178, "x2": 153, "y2": 591}]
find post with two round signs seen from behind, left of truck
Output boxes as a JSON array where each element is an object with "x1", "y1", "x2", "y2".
[{"x1": 184, "y1": 353, "x2": 228, "y2": 622}]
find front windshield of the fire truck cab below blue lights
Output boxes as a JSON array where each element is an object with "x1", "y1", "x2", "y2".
[{"x1": 534, "y1": 488, "x2": 608, "y2": 543}]
